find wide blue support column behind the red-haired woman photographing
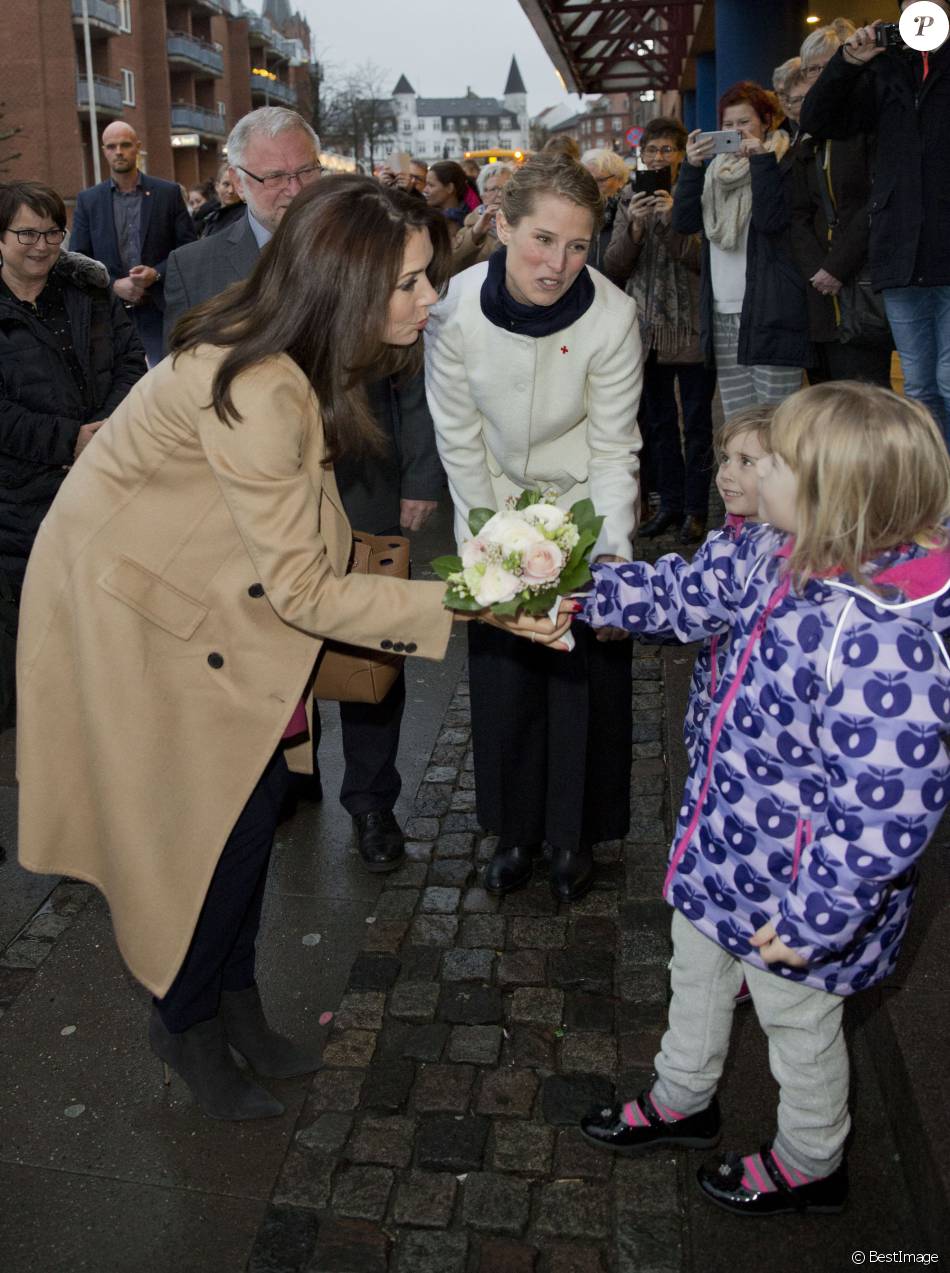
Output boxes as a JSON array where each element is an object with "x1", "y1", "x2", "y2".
[{"x1": 703, "y1": 0, "x2": 809, "y2": 100}]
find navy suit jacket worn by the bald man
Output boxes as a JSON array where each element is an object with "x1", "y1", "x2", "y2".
[{"x1": 69, "y1": 173, "x2": 195, "y2": 309}]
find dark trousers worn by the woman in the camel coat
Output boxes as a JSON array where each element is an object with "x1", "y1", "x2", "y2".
[{"x1": 155, "y1": 749, "x2": 289, "y2": 1034}]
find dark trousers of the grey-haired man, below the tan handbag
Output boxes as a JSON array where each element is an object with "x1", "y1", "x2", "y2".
[{"x1": 313, "y1": 672, "x2": 406, "y2": 817}]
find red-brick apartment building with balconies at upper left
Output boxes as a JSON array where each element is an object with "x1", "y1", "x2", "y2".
[{"x1": 0, "y1": 0, "x2": 311, "y2": 204}]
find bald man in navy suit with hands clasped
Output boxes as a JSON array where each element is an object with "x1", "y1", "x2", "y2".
[{"x1": 70, "y1": 121, "x2": 195, "y2": 367}]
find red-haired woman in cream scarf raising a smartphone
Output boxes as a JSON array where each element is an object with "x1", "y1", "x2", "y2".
[{"x1": 672, "y1": 80, "x2": 811, "y2": 418}]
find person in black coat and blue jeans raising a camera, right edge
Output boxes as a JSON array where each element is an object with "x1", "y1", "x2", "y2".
[{"x1": 801, "y1": 0, "x2": 950, "y2": 443}]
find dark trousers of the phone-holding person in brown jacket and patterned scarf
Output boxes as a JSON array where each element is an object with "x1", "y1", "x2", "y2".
[{"x1": 639, "y1": 350, "x2": 716, "y2": 521}]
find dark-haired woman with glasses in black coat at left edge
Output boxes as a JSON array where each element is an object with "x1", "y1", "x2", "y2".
[{"x1": 0, "y1": 181, "x2": 145, "y2": 593}]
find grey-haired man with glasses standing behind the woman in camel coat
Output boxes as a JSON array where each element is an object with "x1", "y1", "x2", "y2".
[{"x1": 166, "y1": 106, "x2": 443, "y2": 871}]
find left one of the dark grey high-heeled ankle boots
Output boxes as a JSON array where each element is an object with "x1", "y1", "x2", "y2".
[{"x1": 149, "y1": 1007, "x2": 284, "y2": 1123}]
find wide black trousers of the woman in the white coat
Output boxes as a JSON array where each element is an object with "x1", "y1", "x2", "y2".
[{"x1": 469, "y1": 624, "x2": 633, "y2": 849}]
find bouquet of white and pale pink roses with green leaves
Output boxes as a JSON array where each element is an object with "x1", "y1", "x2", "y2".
[{"x1": 432, "y1": 490, "x2": 604, "y2": 615}]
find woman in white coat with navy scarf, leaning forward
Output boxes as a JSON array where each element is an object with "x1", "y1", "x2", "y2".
[{"x1": 425, "y1": 153, "x2": 643, "y2": 901}]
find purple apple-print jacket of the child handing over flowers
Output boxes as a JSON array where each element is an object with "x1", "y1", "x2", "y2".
[{"x1": 578, "y1": 526, "x2": 950, "y2": 994}]
